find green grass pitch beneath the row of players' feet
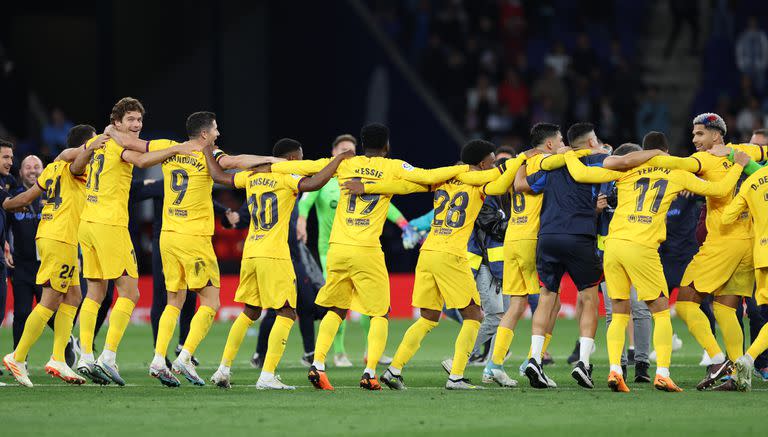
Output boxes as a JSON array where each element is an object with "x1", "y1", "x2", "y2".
[{"x1": 0, "y1": 320, "x2": 768, "y2": 437}]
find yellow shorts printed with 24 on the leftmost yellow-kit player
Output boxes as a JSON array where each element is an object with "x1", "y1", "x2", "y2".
[{"x1": 35, "y1": 238, "x2": 80, "y2": 293}]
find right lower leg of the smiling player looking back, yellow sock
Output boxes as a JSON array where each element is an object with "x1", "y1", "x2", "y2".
[{"x1": 94, "y1": 275, "x2": 139, "y2": 386}]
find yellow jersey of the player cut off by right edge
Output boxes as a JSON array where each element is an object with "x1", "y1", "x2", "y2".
[{"x1": 722, "y1": 167, "x2": 768, "y2": 268}]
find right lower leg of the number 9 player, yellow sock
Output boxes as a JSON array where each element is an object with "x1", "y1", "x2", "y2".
[{"x1": 171, "y1": 285, "x2": 221, "y2": 386}]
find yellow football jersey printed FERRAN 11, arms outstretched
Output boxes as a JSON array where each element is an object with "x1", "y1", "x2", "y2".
[{"x1": 566, "y1": 154, "x2": 743, "y2": 248}]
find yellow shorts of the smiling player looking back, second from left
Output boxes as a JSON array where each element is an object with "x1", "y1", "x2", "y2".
[{"x1": 77, "y1": 220, "x2": 139, "y2": 279}]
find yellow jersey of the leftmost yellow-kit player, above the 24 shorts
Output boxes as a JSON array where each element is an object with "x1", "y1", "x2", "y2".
[{"x1": 35, "y1": 161, "x2": 85, "y2": 246}]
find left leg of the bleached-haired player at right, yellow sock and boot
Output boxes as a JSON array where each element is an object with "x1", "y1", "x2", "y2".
[{"x1": 675, "y1": 286, "x2": 733, "y2": 390}]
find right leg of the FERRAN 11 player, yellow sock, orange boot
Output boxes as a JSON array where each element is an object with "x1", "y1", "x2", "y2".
[{"x1": 646, "y1": 295, "x2": 683, "y2": 392}]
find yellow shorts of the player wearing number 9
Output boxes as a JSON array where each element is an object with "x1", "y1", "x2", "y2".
[{"x1": 160, "y1": 231, "x2": 221, "y2": 291}]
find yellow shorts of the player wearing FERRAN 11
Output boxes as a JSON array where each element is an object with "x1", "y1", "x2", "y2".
[{"x1": 603, "y1": 237, "x2": 669, "y2": 301}]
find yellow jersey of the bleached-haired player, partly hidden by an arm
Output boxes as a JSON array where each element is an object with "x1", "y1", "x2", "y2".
[{"x1": 648, "y1": 144, "x2": 768, "y2": 239}]
